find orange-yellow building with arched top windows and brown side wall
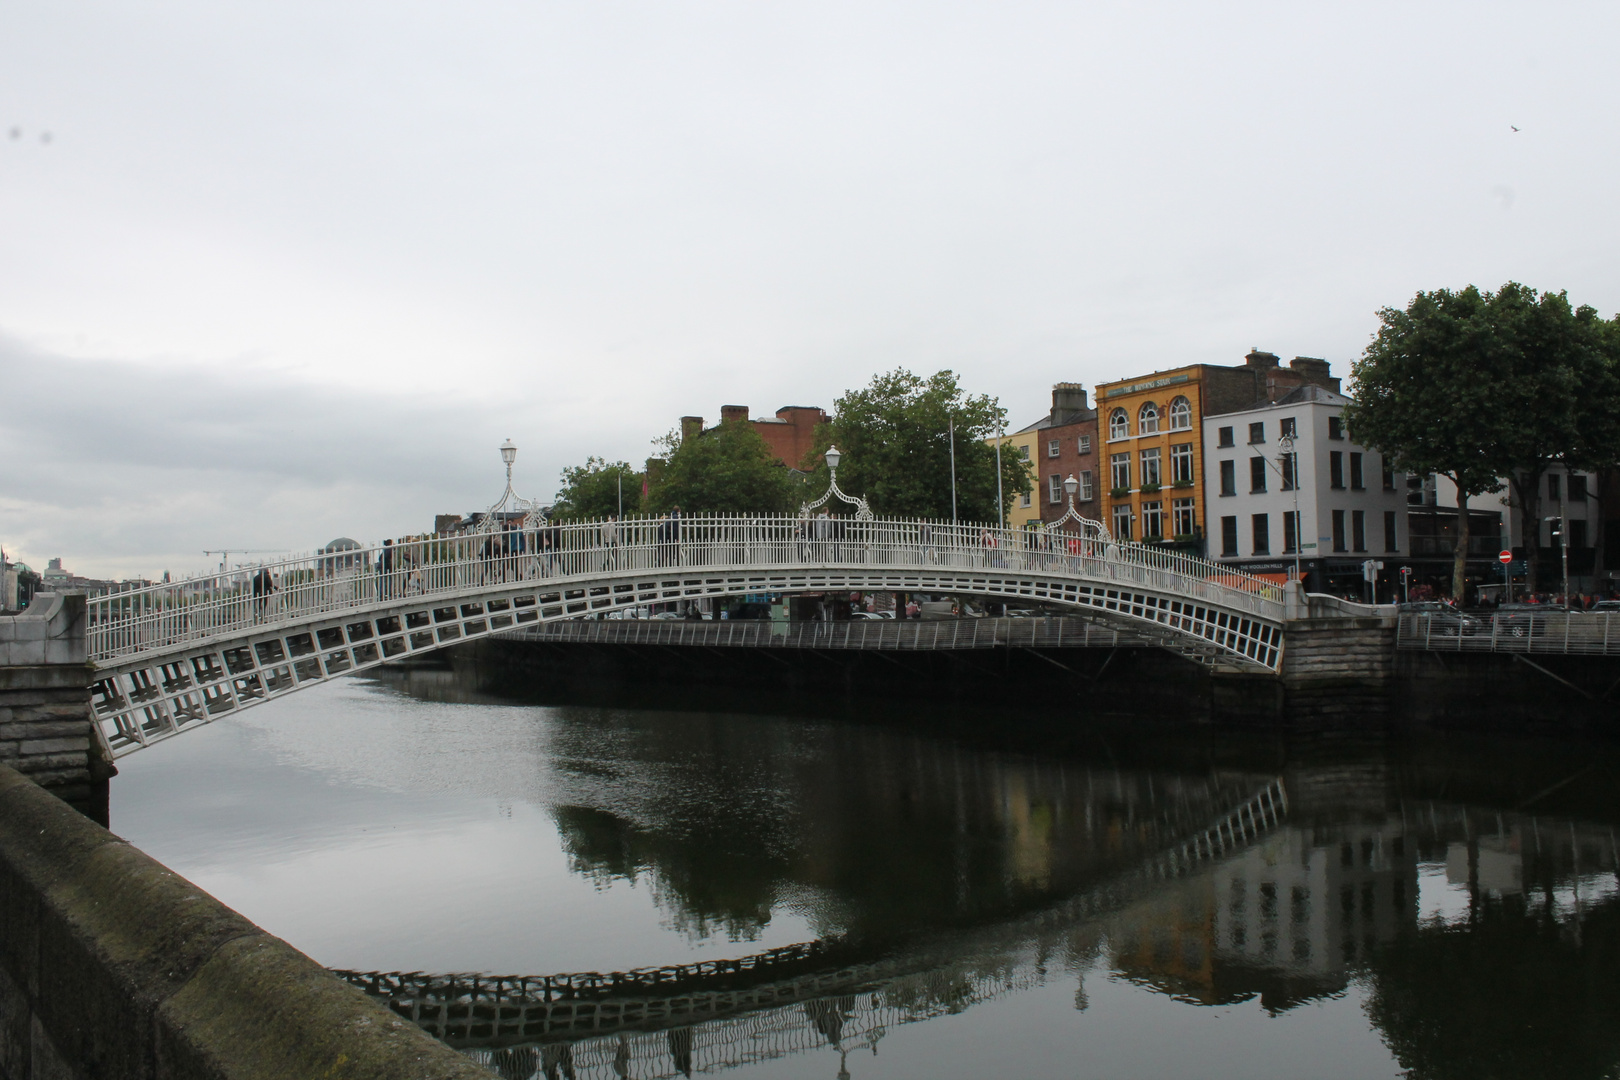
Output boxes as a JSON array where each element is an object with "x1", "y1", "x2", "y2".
[{"x1": 1097, "y1": 350, "x2": 1338, "y2": 554}]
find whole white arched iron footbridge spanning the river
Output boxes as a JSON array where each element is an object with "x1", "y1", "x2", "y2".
[{"x1": 87, "y1": 513, "x2": 1283, "y2": 755}]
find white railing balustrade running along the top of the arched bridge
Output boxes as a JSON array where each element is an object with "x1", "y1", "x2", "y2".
[{"x1": 89, "y1": 517, "x2": 1281, "y2": 661}]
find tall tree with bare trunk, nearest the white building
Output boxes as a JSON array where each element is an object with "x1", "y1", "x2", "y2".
[{"x1": 1345, "y1": 285, "x2": 1513, "y2": 602}]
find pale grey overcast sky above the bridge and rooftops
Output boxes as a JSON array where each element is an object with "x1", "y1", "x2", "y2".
[{"x1": 0, "y1": 0, "x2": 1620, "y2": 575}]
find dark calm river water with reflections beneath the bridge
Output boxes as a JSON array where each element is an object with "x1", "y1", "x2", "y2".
[{"x1": 112, "y1": 669, "x2": 1620, "y2": 1080}]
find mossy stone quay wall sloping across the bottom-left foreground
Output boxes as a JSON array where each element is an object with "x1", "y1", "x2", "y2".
[{"x1": 0, "y1": 766, "x2": 492, "y2": 1080}]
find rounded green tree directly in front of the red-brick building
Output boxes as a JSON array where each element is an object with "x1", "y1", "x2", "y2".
[{"x1": 646, "y1": 419, "x2": 804, "y2": 513}]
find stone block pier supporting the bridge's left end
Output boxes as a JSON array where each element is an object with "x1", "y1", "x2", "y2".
[{"x1": 0, "y1": 593, "x2": 117, "y2": 824}]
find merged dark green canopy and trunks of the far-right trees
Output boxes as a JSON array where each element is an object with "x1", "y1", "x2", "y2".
[{"x1": 1345, "y1": 282, "x2": 1620, "y2": 597}]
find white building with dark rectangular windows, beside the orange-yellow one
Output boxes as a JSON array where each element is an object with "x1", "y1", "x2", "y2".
[{"x1": 1204, "y1": 385, "x2": 1408, "y2": 570}]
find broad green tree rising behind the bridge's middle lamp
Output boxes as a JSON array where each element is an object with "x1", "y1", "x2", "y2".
[{"x1": 800, "y1": 368, "x2": 1030, "y2": 521}]
